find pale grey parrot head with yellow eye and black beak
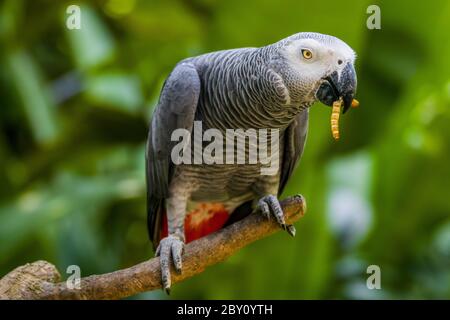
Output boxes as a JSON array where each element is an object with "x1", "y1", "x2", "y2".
[{"x1": 272, "y1": 33, "x2": 357, "y2": 113}]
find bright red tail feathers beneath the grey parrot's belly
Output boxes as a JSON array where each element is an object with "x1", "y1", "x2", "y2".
[{"x1": 161, "y1": 202, "x2": 230, "y2": 243}]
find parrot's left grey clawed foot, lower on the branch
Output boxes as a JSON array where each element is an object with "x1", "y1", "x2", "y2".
[{"x1": 155, "y1": 234, "x2": 184, "y2": 294}]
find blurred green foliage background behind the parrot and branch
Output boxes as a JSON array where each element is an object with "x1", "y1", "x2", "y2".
[{"x1": 0, "y1": 0, "x2": 450, "y2": 299}]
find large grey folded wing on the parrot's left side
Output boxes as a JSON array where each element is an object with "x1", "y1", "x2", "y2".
[{"x1": 146, "y1": 63, "x2": 201, "y2": 248}]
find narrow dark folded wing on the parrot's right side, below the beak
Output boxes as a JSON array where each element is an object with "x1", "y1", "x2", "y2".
[{"x1": 278, "y1": 109, "x2": 309, "y2": 195}]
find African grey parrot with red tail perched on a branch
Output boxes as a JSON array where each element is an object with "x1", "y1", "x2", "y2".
[{"x1": 146, "y1": 33, "x2": 356, "y2": 292}]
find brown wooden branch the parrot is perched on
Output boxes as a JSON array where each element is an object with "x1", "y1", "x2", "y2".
[{"x1": 0, "y1": 195, "x2": 306, "y2": 299}]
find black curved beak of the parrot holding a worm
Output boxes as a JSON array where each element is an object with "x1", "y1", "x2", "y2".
[{"x1": 316, "y1": 63, "x2": 356, "y2": 113}]
